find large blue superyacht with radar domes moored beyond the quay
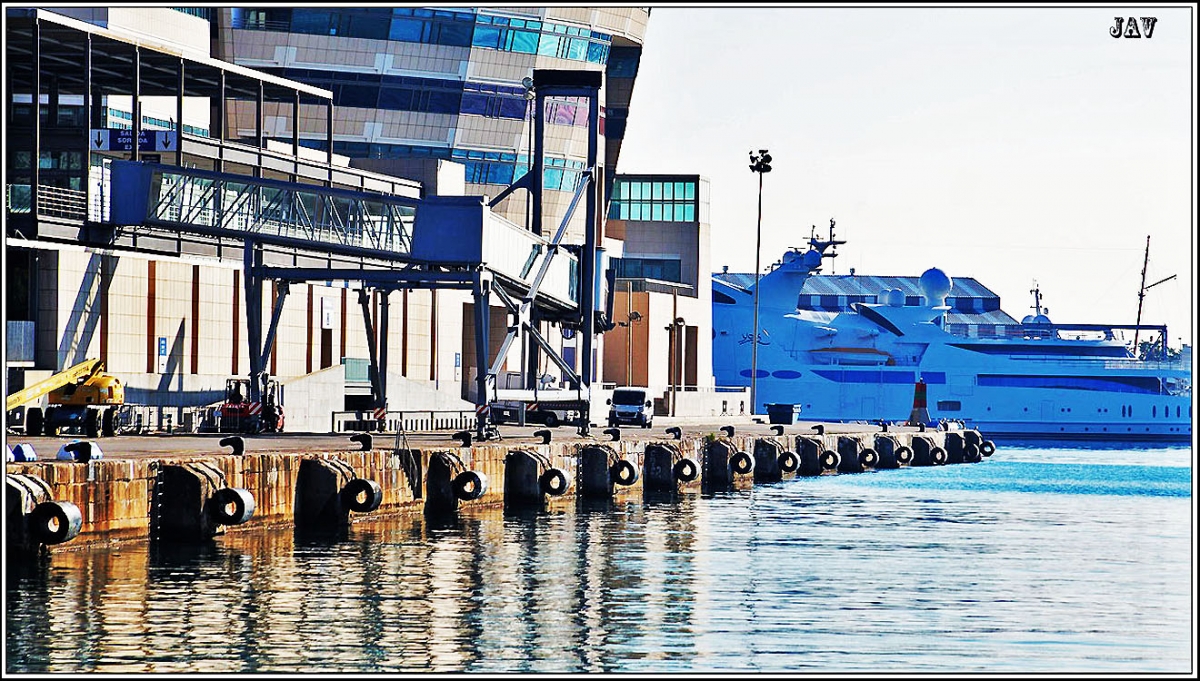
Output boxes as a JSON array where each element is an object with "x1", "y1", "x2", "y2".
[{"x1": 713, "y1": 221, "x2": 1192, "y2": 442}]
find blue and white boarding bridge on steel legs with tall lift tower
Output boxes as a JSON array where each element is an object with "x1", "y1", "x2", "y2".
[{"x1": 110, "y1": 70, "x2": 611, "y2": 439}]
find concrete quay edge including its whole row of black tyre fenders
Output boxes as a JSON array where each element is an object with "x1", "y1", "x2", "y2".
[{"x1": 6, "y1": 427, "x2": 995, "y2": 552}]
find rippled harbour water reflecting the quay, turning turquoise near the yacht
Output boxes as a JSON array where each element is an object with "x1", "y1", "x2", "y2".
[{"x1": 5, "y1": 447, "x2": 1195, "y2": 674}]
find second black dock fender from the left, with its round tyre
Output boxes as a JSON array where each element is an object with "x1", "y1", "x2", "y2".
[{"x1": 150, "y1": 462, "x2": 254, "y2": 543}]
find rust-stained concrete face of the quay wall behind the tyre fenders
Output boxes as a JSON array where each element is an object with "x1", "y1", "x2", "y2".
[{"x1": 6, "y1": 432, "x2": 990, "y2": 550}]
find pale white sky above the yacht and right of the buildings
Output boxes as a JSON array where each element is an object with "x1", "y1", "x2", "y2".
[{"x1": 618, "y1": 5, "x2": 1196, "y2": 346}]
